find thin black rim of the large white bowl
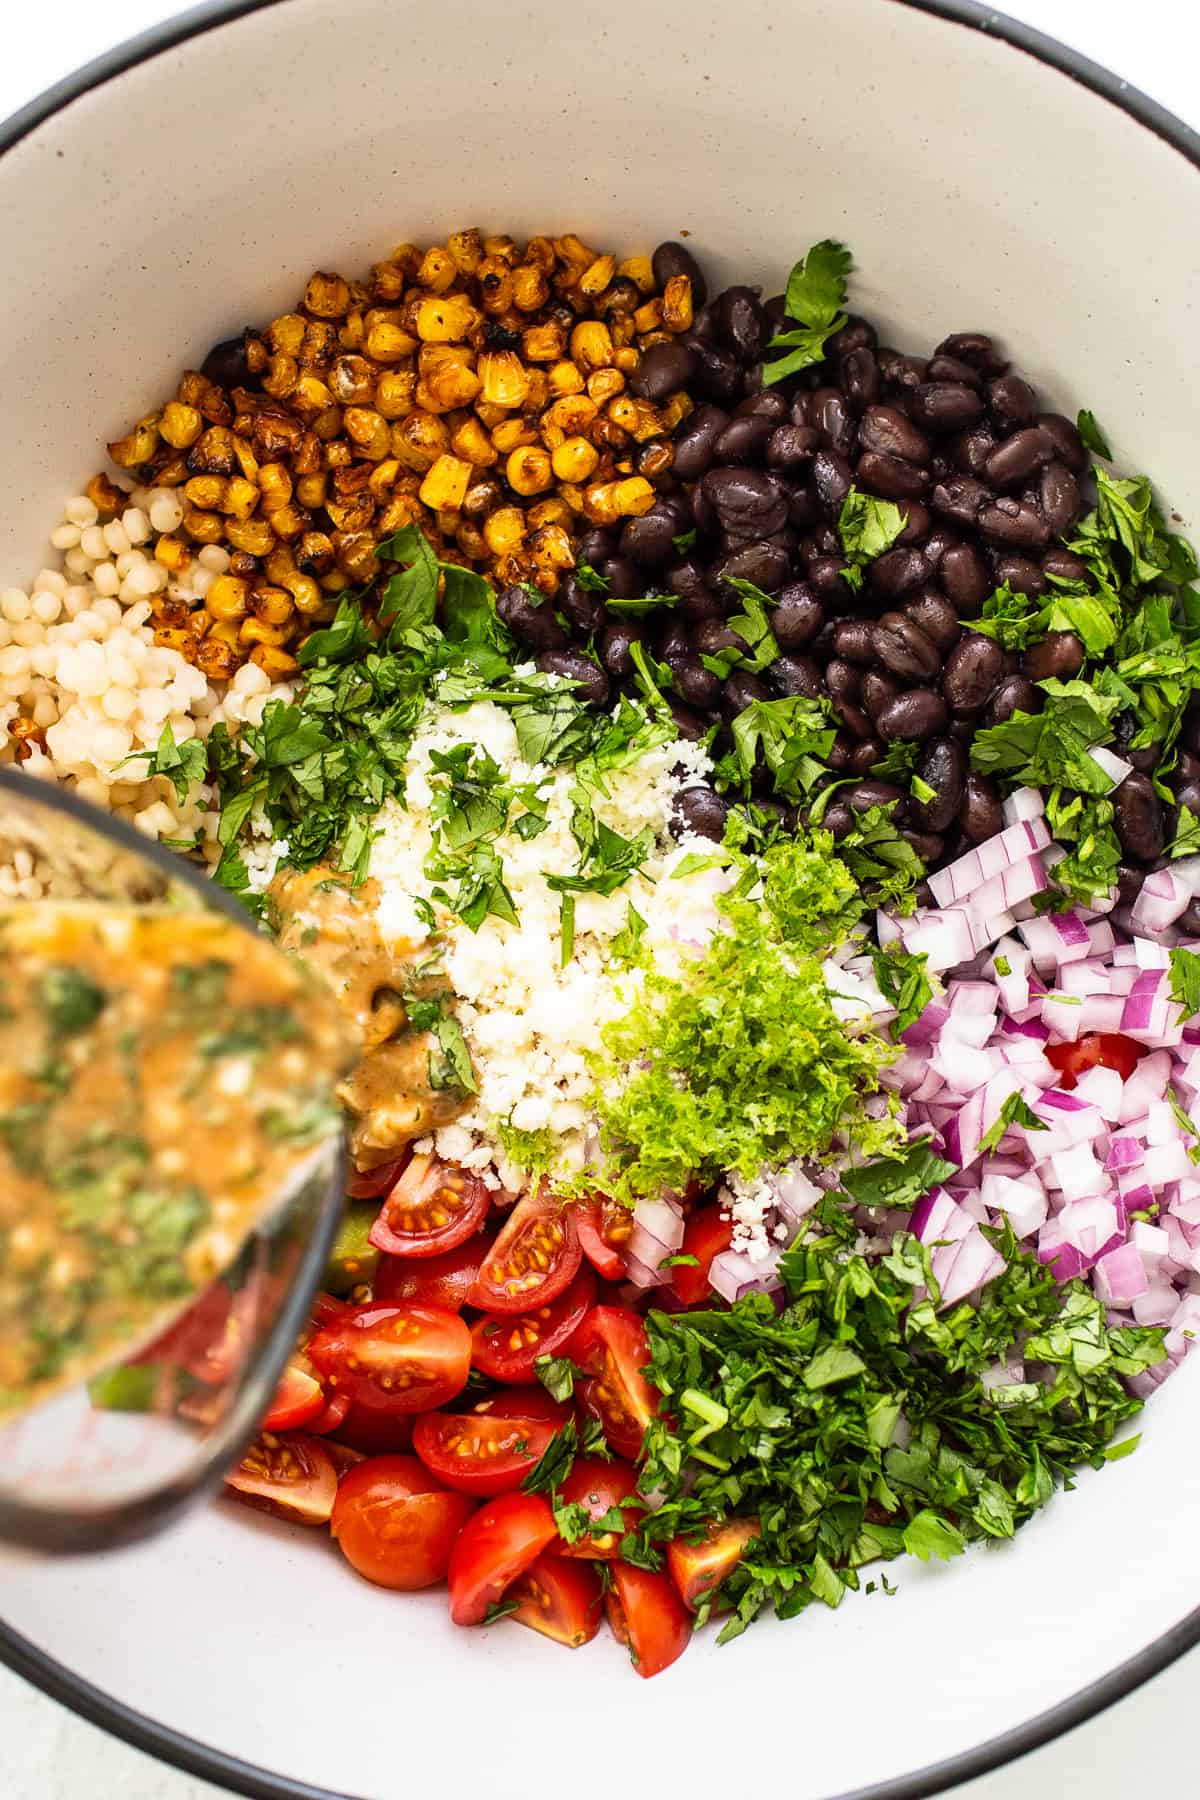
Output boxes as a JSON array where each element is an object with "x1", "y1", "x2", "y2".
[{"x1": 0, "y1": 0, "x2": 1200, "y2": 1800}]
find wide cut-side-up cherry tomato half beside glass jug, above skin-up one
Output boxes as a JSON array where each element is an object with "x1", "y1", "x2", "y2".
[{"x1": 308, "y1": 1301, "x2": 471, "y2": 1413}]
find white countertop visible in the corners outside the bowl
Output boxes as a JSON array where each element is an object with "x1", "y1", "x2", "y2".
[{"x1": 0, "y1": 0, "x2": 1200, "y2": 1800}]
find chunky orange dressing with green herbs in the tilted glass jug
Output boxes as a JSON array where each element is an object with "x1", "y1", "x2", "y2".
[{"x1": 0, "y1": 904, "x2": 354, "y2": 1417}]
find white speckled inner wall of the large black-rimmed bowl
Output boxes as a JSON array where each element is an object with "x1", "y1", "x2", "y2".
[{"x1": 0, "y1": 0, "x2": 1200, "y2": 1800}]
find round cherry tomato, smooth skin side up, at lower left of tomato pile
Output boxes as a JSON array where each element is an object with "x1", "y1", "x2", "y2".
[{"x1": 329, "y1": 1456, "x2": 475, "y2": 1593}]
